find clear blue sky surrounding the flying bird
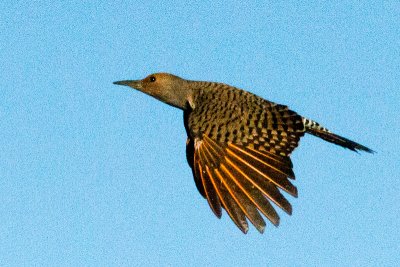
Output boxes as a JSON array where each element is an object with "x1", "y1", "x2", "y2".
[{"x1": 0, "y1": 0, "x2": 400, "y2": 266}]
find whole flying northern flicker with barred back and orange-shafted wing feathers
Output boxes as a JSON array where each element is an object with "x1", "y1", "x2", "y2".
[{"x1": 114, "y1": 73, "x2": 373, "y2": 233}]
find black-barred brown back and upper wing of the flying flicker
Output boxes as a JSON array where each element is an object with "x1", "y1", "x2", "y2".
[{"x1": 187, "y1": 82, "x2": 305, "y2": 156}]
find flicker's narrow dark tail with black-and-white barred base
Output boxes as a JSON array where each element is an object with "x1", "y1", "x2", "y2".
[{"x1": 303, "y1": 118, "x2": 375, "y2": 153}]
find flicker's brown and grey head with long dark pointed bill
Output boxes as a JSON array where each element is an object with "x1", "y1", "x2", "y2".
[{"x1": 114, "y1": 73, "x2": 190, "y2": 109}]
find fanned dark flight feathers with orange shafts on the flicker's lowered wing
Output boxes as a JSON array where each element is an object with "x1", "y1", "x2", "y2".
[{"x1": 188, "y1": 135, "x2": 297, "y2": 233}]
